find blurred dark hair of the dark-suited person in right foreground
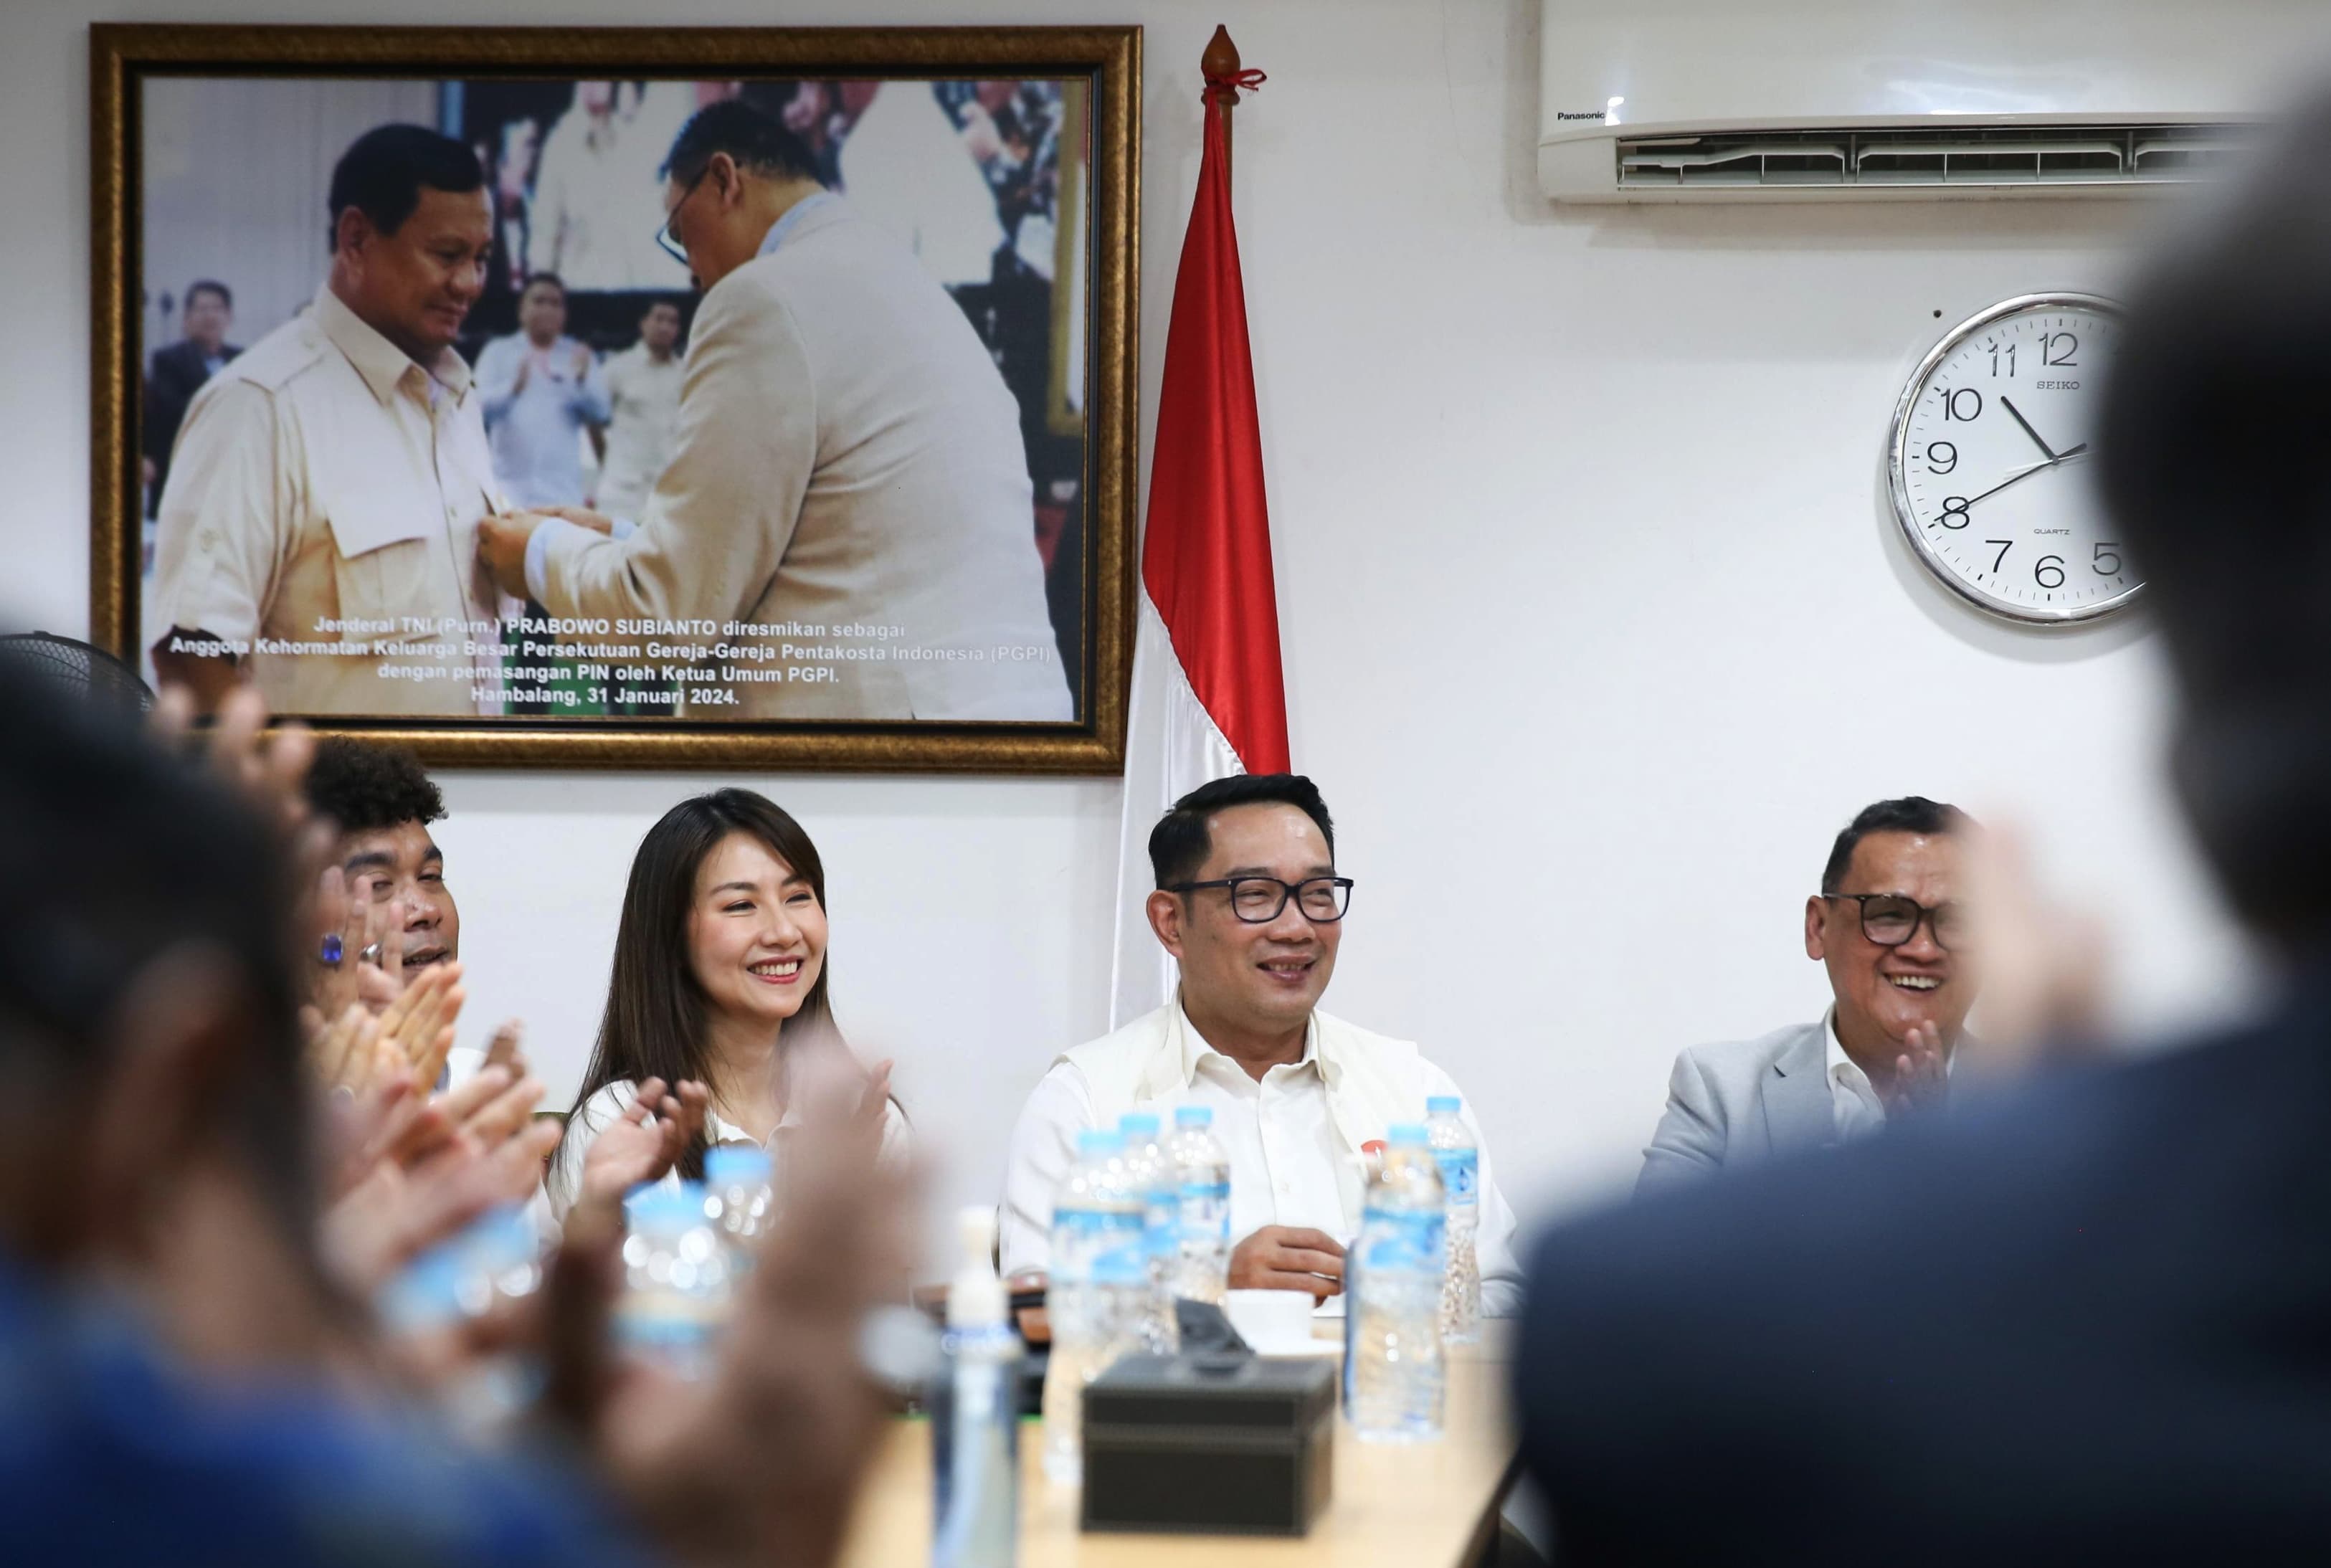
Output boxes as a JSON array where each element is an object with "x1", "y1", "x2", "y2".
[{"x1": 2096, "y1": 98, "x2": 2331, "y2": 941}]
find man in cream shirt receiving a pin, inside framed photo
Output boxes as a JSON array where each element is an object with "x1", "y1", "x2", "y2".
[{"x1": 147, "y1": 125, "x2": 496, "y2": 718}]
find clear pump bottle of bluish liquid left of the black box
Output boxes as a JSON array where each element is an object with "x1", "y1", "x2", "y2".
[{"x1": 930, "y1": 1207, "x2": 1021, "y2": 1568}]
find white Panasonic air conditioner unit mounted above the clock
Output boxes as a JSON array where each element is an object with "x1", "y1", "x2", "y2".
[{"x1": 1539, "y1": 0, "x2": 2331, "y2": 203}]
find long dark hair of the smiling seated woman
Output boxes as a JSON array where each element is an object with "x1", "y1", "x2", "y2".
[{"x1": 566, "y1": 790, "x2": 839, "y2": 1179}]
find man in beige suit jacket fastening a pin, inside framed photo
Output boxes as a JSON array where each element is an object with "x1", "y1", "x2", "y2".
[{"x1": 478, "y1": 100, "x2": 1075, "y2": 722}]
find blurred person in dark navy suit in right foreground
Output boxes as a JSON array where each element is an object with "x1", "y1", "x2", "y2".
[{"x1": 1515, "y1": 100, "x2": 2331, "y2": 1566}]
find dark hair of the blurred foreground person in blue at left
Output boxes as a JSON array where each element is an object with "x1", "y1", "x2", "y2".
[{"x1": 0, "y1": 680, "x2": 317, "y2": 1260}]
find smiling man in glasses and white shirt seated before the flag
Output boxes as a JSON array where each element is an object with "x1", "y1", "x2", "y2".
[{"x1": 1000, "y1": 774, "x2": 1520, "y2": 1314}]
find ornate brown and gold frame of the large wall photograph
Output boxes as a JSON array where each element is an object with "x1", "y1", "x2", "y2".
[{"x1": 91, "y1": 23, "x2": 1142, "y2": 774}]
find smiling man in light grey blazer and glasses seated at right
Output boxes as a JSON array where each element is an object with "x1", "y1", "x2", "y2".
[{"x1": 1636, "y1": 794, "x2": 1977, "y2": 1193}]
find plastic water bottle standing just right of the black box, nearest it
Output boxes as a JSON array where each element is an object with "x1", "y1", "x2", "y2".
[{"x1": 1343, "y1": 1123, "x2": 1448, "y2": 1443}]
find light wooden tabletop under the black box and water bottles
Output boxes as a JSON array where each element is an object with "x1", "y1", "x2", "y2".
[{"x1": 842, "y1": 1321, "x2": 1515, "y2": 1568}]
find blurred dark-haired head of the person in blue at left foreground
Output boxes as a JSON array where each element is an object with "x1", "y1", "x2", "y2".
[{"x1": 0, "y1": 680, "x2": 322, "y2": 1361}]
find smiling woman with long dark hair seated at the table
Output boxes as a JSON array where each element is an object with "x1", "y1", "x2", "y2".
[{"x1": 546, "y1": 790, "x2": 907, "y2": 1216}]
